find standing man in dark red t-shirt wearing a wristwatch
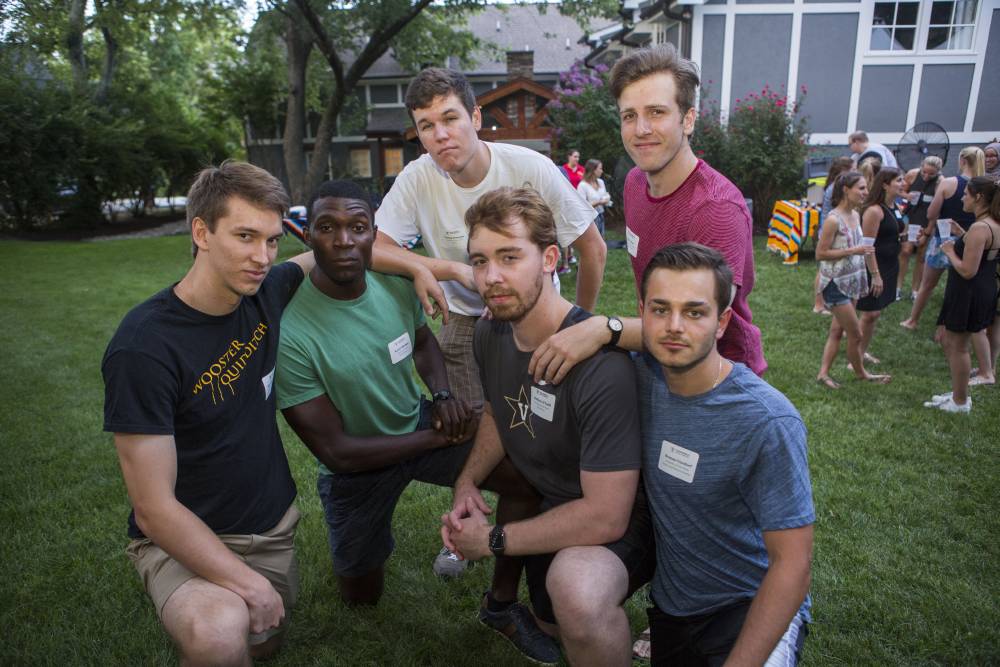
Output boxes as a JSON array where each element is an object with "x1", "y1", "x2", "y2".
[{"x1": 530, "y1": 44, "x2": 767, "y2": 383}]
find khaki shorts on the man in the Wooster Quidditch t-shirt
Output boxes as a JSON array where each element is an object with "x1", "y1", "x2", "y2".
[{"x1": 125, "y1": 503, "x2": 301, "y2": 644}]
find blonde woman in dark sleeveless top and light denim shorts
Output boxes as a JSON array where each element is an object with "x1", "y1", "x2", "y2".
[{"x1": 899, "y1": 146, "x2": 986, "y2": 331}]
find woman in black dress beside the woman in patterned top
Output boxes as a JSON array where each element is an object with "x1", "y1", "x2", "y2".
[{"x1": 857, "y1": 167, "x2": 906, "y2": 364}]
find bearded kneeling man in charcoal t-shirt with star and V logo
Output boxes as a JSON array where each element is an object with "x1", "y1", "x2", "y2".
[{"x1": 442, "y1": 188, "x2": 654, "y2": 666}]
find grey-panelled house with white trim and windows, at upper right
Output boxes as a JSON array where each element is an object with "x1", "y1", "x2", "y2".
[{"x1": 586, "y1": 0, "x2": 1000, "y2": 170}]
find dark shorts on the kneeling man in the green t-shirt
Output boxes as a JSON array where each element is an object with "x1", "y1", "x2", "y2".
[{"x1": 316, "y1": 400, "x2": 472, "y2": 577}]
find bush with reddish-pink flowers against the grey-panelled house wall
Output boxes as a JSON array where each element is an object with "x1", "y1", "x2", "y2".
[{"x1": 691, "y1": 86, "x2": 809, "y2": 231}]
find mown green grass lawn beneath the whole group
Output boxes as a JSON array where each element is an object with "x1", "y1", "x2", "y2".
[{"x1": 0, "y1": 232, "x2": 1000, "y2": 666}]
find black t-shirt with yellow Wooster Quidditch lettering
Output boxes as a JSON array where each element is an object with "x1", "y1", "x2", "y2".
[{"x1": 101, "y1": 262, "x2": 303, "y2": 537}]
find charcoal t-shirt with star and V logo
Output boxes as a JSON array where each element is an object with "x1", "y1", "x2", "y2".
[{"x1": 473, "y1": 306, "x2": 642, "y2": 507}]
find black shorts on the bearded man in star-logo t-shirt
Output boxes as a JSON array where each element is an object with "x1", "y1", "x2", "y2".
[{"x1": 524, "y1": 479, "x2": 656, "y2": 623}]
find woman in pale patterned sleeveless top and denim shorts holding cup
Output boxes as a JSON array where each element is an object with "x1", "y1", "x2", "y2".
[{"x1": 816, "y1": 171, "x2": 891, "y2": 389}]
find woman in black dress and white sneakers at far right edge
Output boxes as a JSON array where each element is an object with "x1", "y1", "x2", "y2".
[{"x1": 924, "y1": 176, "x2": 1000, "y2": 413}]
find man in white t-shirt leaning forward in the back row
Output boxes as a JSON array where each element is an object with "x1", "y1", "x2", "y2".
[{"x1": 372, "y1": 67, "x2": 607, "y2": 410}]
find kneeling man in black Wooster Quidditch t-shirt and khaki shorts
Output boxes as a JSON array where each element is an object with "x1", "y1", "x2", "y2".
[{"x1": 102, "y1": 162, "x2": 313, "y2": 665}]
